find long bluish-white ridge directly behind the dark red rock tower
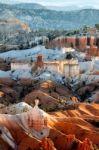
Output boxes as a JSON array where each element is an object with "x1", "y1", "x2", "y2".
[{"x1": 0, "y1": 46, "x2": 62, "y2": 60}]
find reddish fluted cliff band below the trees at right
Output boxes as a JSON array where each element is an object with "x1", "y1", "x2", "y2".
[{"x1": 45, "y1": 36, "x2": 99, "y2": 53}]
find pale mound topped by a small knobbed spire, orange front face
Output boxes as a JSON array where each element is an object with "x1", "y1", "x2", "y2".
[{"x1": 16, "y1": 101, "x2": 49, "y2": 139}]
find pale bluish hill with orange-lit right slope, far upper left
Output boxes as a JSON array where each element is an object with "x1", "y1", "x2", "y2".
[{"x1": 0, "y1": 15, "x2": 31, "y2": 51}]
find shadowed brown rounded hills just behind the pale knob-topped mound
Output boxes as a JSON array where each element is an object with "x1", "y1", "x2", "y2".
[{"x1": 0, "y1": 78, "x2": 99, "y2": 110}]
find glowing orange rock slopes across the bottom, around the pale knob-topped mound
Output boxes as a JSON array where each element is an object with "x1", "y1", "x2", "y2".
[{"x1": 0, "y1": 104, "x2": 99, "y2": 150}]
